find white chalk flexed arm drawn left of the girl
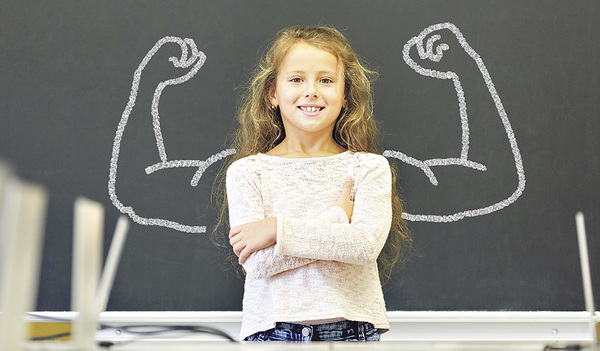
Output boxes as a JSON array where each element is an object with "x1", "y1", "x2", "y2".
[{"x1": 108, "y1": 36, "x2": 235, "y2": 233}]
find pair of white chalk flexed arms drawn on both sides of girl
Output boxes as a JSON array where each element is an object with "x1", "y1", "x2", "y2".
[{"x1": 108, "y1": 23, "x2": 525, "y2": 233}]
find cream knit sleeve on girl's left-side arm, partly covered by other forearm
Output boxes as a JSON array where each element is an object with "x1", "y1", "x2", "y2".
[{"x1": 226, "y1": 159, "x2": 318, "y2": 278}]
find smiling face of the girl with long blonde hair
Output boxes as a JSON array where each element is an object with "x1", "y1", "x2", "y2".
[{"x1": 270, "y1": 43, "x2": 345, "y2": 144}]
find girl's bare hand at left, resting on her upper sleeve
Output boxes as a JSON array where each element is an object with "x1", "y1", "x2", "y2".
[{"x1": 229, "y1": 217, "x2": 277, "y2": 264}]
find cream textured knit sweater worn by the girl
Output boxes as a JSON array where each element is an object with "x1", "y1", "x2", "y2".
[{"x1": 227, "y1": 151, "x2": 392, "y2": 339}]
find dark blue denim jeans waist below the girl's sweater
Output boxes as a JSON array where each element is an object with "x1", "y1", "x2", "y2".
[{"x1": 244, "y1": 321, "x2": 380, "y2": 342}]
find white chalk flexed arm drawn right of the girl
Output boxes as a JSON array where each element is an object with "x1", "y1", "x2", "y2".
[{"x1": 383, "y1": 23, "x2": 525, "y2": 222}]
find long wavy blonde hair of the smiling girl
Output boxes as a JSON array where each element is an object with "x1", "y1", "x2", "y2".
[{"x1": 213, "y1": 26, "x2": 412, "y2": 282}]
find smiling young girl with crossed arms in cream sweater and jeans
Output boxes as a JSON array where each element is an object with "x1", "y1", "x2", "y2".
[{"x1": 218, "y1": 26, "x2": 410, "y2": 341}]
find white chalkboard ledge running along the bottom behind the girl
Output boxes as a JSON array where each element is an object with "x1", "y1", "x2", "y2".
[{"x1": 29, "y1": 311, "x2": 600, "y2": 343}]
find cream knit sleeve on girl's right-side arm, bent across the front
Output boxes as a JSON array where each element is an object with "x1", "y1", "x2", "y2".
[{"x1": 275, "y1": 154, "x2": 392, "y2": 264}]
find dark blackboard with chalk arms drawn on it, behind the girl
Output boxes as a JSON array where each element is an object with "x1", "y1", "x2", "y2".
[{"x1": 0, "y1": 0, "x2": 600, "y2": 311}]
